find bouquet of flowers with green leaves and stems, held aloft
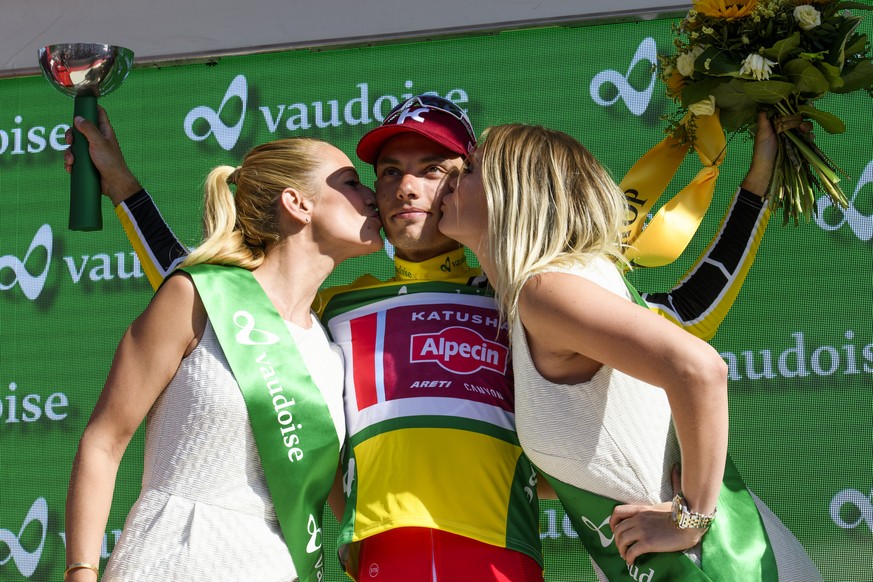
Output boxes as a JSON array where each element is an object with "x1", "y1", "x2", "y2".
[{"x1": 659, "y1": 0, "x2": 873, "y2": 224}]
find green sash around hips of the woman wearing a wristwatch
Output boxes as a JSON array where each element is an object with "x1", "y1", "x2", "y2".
[{"x1": 540, "y1": 458, "x2": 779, "y2": 582}]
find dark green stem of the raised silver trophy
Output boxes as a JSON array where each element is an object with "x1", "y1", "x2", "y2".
[{"x1": 69, "y1": 95, "x2": 103, "y2": 231}]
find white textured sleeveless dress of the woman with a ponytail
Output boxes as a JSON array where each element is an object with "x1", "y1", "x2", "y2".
[{"x1": 101, "y1": 315, "x2": 345, "y2": 582}]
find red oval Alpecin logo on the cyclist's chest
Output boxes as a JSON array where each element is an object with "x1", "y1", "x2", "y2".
[{"x1": 409, "y1": 326, "x2": 508, "y2": 374}]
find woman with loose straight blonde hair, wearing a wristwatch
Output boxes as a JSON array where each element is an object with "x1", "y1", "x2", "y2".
[{"x1": 440, "y1": 118, "x2": 821, "y2": 582}]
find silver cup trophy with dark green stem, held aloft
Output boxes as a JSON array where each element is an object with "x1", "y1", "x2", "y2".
[{"x1": 39, "y1": 43, "x2": 133, "y2": 231}]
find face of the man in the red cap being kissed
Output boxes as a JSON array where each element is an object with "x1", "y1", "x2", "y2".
[{"x1": 375, "y1": 133, "x2": 463, "y2": 262}]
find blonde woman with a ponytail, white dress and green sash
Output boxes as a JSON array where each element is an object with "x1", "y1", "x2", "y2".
[{"x1": 64, "y1": 138, "x2": 382, "y2": 582}]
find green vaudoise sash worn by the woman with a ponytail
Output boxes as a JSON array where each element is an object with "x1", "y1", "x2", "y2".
[{"x1": 183, "y1": 265, "x2": 340, "y2": 582}]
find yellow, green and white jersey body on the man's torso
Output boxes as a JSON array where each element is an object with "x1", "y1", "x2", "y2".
[{"x1": 321, "y1": 248, "x2": 543, "y2": 572}]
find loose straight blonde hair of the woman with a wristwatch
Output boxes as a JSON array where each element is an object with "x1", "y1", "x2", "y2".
[{"x1": 478, "y1": 124, "x2": 627, "y2": 326}]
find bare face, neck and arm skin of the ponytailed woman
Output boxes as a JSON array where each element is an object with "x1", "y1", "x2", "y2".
[{"x1": 65, "y1": 145, "x2": 382, "y2": 582}]
